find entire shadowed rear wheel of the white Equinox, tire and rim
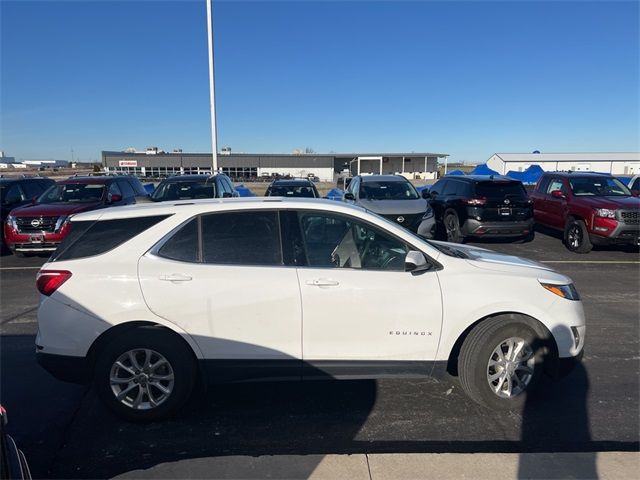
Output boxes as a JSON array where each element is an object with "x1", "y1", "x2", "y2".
[{"x1": 94, "y1": 327, "x2": 196, "y2": 421}]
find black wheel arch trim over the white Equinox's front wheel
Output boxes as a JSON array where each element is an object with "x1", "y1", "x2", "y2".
[{"x1": 446, "y1": 312, "x2": 559, "y2": 376}]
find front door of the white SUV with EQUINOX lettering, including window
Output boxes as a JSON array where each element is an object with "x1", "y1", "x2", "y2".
[{"x1": 297, "y1": 211, "x2": 442, "y2": 378}]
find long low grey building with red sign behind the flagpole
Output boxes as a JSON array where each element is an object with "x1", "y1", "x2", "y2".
[{"x1": 102, "y1": 148, "x2": 448, "y2": 182}]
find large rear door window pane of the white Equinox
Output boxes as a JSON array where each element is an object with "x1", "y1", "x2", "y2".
[{"x1": 201, "y1": 211, "x2": 282, "y2": 265}]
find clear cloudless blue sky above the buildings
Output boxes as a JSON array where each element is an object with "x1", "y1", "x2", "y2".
[{"x1": 0, "y1": 0, "x2": 640, "y2": 162}]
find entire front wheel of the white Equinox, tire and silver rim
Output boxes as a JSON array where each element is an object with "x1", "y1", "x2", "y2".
[{"x1": 458, "y1": 316, "x2": 546, "y2": 410}]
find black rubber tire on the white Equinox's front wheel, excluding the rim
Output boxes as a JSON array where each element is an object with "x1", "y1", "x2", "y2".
[{"x1": 458, "y1": 314, "x2": 548, "y2": 410}]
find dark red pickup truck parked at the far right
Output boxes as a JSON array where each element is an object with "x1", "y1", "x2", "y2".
[{"x1": 531, "y1": 172, "x2": 640, "y2": 253}]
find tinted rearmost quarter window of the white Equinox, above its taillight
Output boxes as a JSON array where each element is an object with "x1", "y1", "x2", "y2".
[{"x1": 50, "y1": 215, "x2": 169, "y2": 261}]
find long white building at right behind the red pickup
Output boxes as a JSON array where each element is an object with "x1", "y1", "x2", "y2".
[{"x1": 487, "y1": 152, "x2": 640, "y2": 175}]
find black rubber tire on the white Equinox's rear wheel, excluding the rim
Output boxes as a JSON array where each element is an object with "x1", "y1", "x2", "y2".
[{"x1": 94, "y1": 327, "x2": 197, "y2": 422}]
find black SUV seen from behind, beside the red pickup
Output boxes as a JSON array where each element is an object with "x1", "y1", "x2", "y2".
[{"x1": 422, "y1": 175, "x2": 534, "y2": 243}]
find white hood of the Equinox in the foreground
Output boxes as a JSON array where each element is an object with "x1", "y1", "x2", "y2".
[{"x1": 430, "y1": 240, "x2": 571, "y2": 284}]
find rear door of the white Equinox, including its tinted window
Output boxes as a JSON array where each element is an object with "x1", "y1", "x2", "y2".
[{"x1": 139, "y1": 210, "x2": 302, "y2": 380}]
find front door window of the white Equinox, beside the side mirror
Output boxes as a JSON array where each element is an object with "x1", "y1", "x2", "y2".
[{"x1": 299, "y1": 212, "x2": 409, "y2": 271}]
